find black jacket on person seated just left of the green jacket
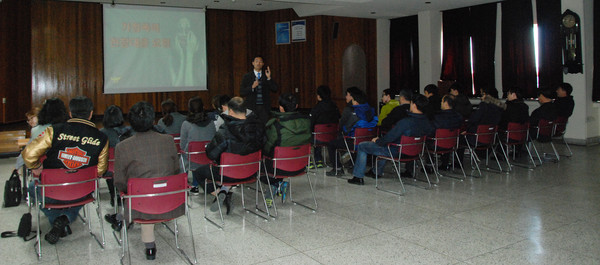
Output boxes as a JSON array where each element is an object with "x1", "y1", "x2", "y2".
[{"x1": 206, "y1": 114, "x2": 266, "y2": 162}]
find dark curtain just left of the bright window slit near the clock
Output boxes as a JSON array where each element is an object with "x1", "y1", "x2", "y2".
[{"x1": 501, "y1": 0, "x2": 537, "y2": 98}]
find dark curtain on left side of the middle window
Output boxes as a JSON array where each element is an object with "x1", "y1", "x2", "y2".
[{"x1": 440, "y1": 7, "x2": 473, "y2": 95}]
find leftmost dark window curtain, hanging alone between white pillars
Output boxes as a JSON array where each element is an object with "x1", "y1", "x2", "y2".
[{"x1": 390, "y1": 16, "x2": 419, "y2": 93}]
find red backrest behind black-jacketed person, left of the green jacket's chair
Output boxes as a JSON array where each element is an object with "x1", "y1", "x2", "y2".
[{"x1": 219, "y1": 151, "x2": 261, "y2": 179}]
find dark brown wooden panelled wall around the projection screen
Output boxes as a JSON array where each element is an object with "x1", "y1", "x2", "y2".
[{"x1": 22, "y1": 0, "x2": 377, "y2": 118}]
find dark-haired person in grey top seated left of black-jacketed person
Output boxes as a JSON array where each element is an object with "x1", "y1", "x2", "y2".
[{"x1": 179, "y1": 97, "x2": 217, "y2": 193}]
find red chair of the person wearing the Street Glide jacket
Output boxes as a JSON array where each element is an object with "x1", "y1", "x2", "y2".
[{"x1": 34, "y1": 166, "x2": 106, "y2": 258}]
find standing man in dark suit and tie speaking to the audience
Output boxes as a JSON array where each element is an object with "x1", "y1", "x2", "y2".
[{"x1": 240, "y1": 56, "x2": 277, "y2": 123}]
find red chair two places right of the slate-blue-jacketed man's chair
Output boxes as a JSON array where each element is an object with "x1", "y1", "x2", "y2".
[{"x1": 464, "y1": 124, "x2": 502, "y2": 176}]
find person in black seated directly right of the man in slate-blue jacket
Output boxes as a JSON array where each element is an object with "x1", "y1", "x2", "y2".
[{"x1": 432, "y1": 95, "x2": 463, "y2": 170}]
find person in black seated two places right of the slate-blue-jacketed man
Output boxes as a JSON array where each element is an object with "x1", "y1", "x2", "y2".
[{"x1": 467, "y1": 87, "x2": 506, "y2": 133}]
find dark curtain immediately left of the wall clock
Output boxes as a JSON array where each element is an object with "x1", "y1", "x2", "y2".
[{"x1": 536, "y1": 0, "x2": 563, "y2": 89}]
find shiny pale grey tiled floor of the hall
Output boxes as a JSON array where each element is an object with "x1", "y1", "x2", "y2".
[{"x1": 0, "y1": 143, "x2": 600, "y2": 264}]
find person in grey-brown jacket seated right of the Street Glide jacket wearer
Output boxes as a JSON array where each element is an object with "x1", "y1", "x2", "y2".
[{"x1": 104, "y1": 101, "x2": 179, "y2": 260}]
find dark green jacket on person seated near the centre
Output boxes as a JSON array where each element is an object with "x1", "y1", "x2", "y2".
[{"x1": 263, "y1": 112, "x2": 311, "y2": 156}]
